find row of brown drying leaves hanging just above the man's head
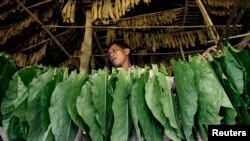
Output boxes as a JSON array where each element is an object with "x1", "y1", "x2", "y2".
[{"x1": 106, "y1": 29, "x2": 211, "y2": 52}]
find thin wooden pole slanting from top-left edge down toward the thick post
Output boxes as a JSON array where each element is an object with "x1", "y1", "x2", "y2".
[{"x1": 16, "y1": 0, "x2": 72, "y2": 59}]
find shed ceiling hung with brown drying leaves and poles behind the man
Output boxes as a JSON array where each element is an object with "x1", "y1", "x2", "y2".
[{"x1": 0, "y1": 0, "x2": 250, "y2": 70}]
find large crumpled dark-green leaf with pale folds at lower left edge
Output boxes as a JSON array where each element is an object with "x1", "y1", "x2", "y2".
[{"x1": 1, "y1": 67, "x2": 38, "y2": 140}]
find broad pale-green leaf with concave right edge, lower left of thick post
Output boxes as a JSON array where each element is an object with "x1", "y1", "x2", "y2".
[{"x1": 49, "y1": 76, "x2": 78, "y2": 141}]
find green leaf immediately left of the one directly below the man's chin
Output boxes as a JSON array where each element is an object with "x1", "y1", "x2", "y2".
[{"x1": 90, "y1": 69, "x2": 112, "y2": 140}]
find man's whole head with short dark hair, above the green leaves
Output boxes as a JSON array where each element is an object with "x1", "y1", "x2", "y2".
[{"x1": 108, "y1": 41, "x2": 131, "y2": 69}]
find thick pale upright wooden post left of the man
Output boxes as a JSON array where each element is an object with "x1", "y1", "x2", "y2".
[{"x1": 80, "y1": 10, "x2": 93, "y2": 72}]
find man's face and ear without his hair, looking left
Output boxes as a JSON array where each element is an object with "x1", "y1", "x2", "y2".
[{"x1": 108, "y1": 44, "x2": 130, "y2": 67}]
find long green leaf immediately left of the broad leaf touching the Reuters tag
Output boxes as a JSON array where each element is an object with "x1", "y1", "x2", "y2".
[{"x1": 171, "y1": 60, "x2": 198, "y2": 141}]
